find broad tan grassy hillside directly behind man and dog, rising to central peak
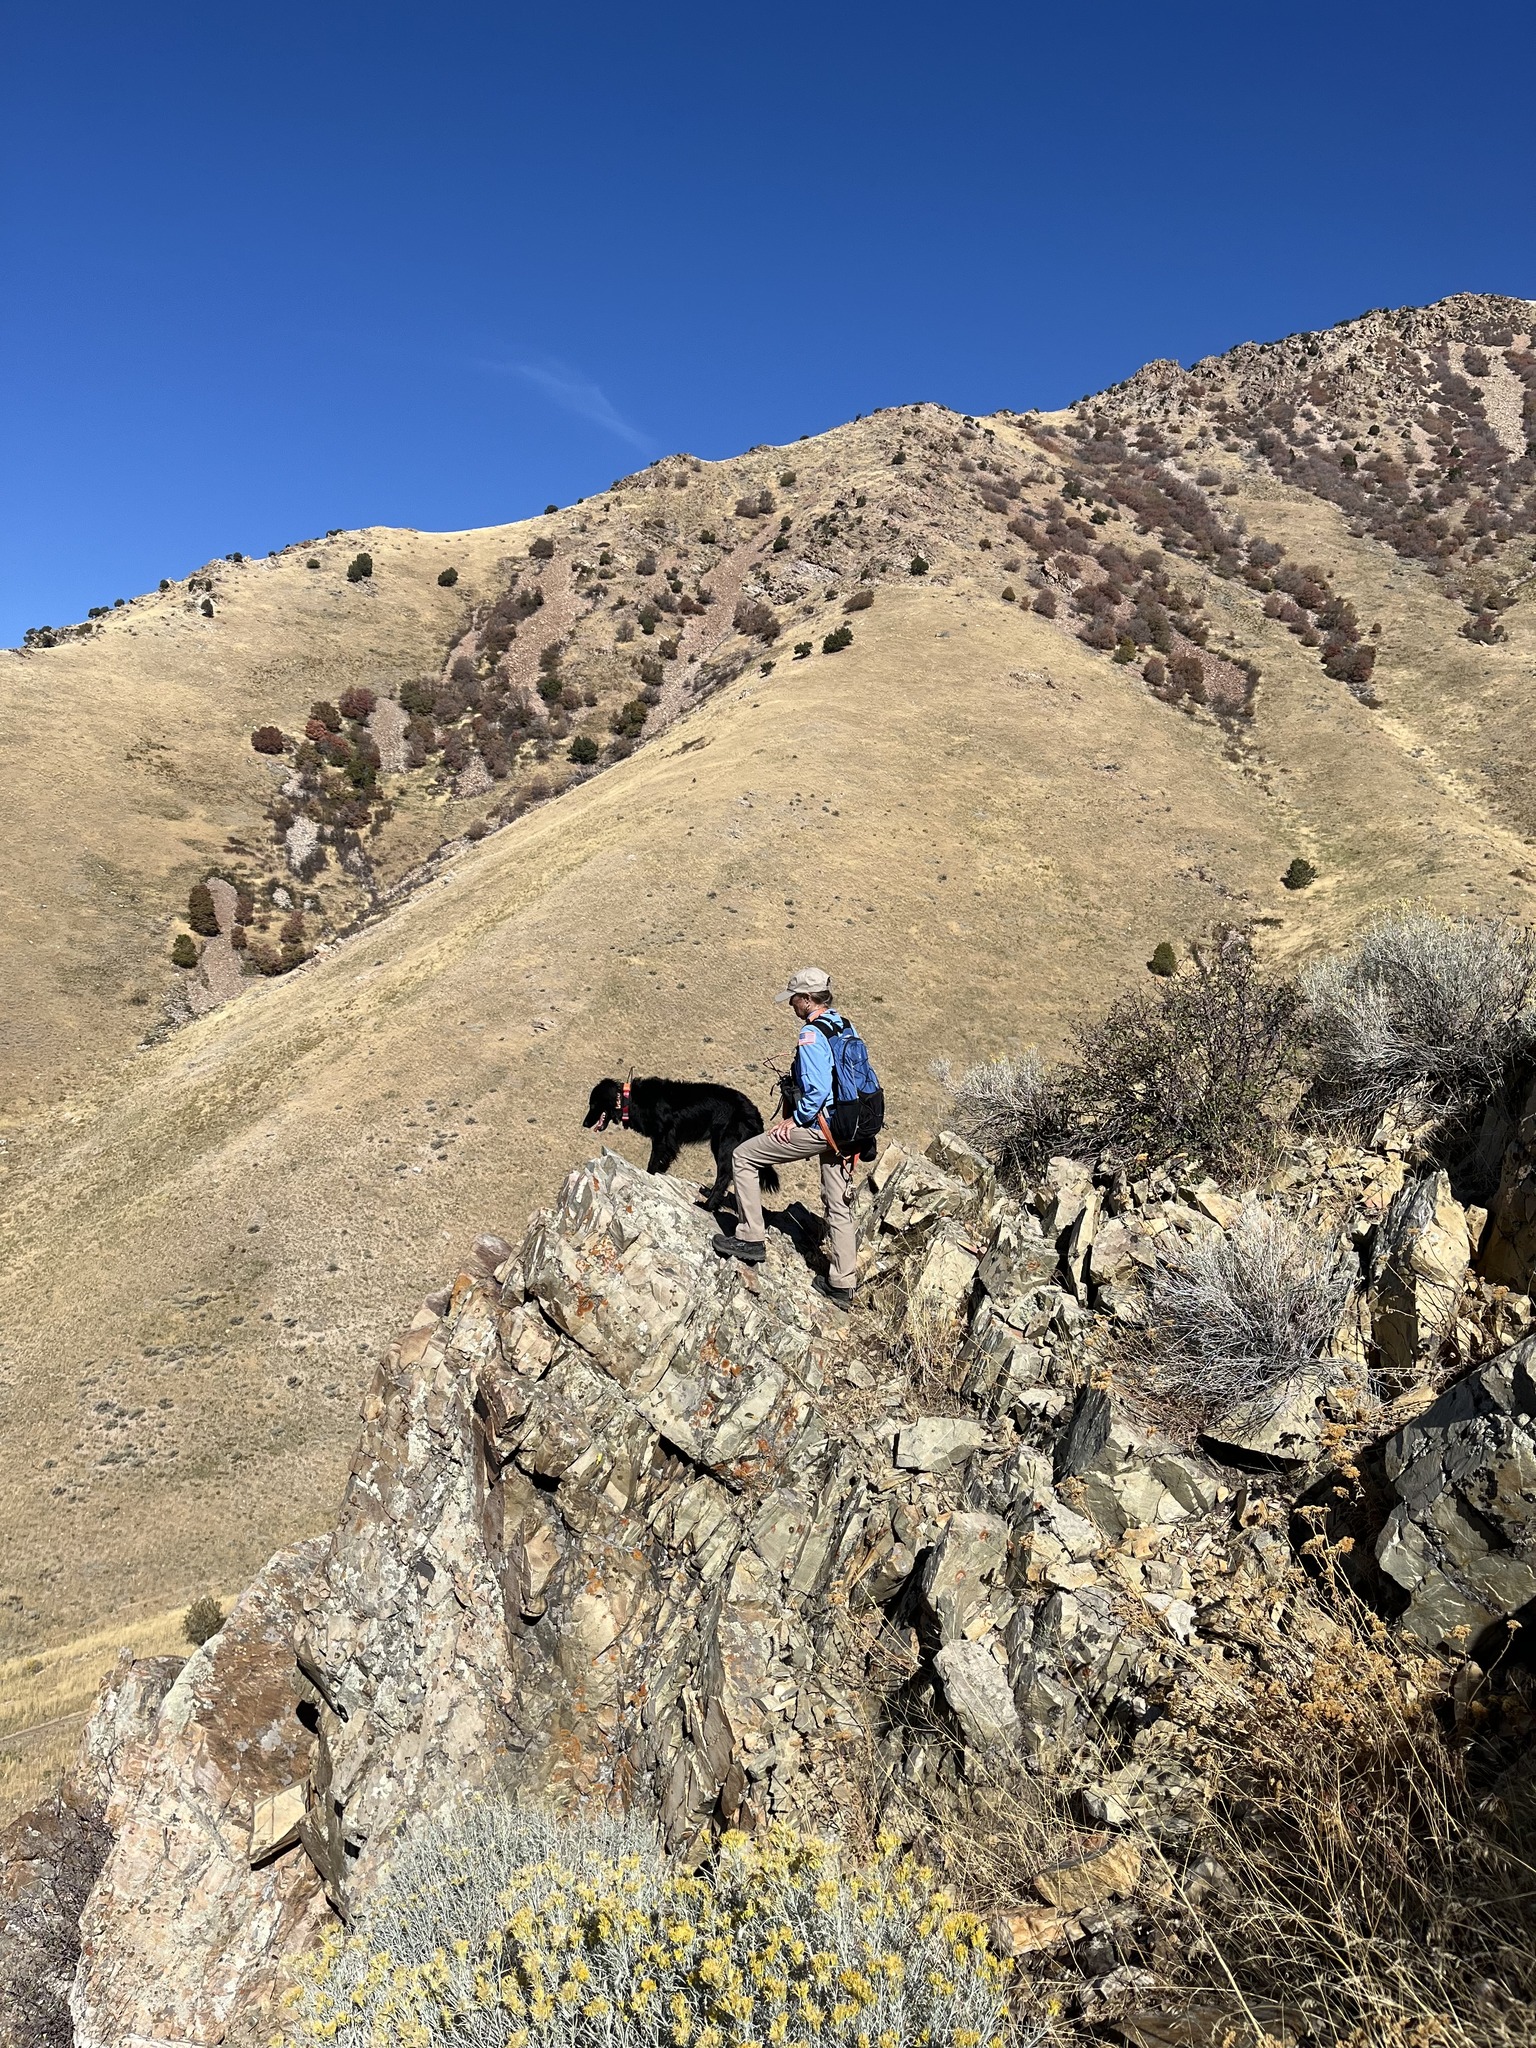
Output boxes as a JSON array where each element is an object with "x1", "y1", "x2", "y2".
[{"x1": 0, "y1": 288, "x2": 1536, "y2": 1679}]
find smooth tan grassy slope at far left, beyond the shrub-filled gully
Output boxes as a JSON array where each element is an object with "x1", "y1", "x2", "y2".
[{"x1": 0, "y1": 526, "x2": 524, "y2": 1116}]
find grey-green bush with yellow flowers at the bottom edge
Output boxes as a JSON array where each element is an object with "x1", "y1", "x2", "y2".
[{"x1": 285, "y1": 1802, "x2": 1016, "y2": 2048}]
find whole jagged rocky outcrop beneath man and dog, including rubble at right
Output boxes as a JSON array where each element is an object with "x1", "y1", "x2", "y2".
[{"x1": 0, "y1": 1092, "x2": 1536, "y2": 2048}]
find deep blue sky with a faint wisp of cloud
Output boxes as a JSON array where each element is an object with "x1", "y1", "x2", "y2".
[{"x1": 0, "y1": 0, "x2": 1536, "y2": 643}]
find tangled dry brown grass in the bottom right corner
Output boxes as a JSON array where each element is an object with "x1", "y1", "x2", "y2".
[{"x1": 1169, "y1": 1610, "x2": 1536, "y2": 2048}]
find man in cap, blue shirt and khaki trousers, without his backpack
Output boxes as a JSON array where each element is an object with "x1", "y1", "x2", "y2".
[{"x1": 715, "y1": 967, "x2": 858, "y2": 1311}]
